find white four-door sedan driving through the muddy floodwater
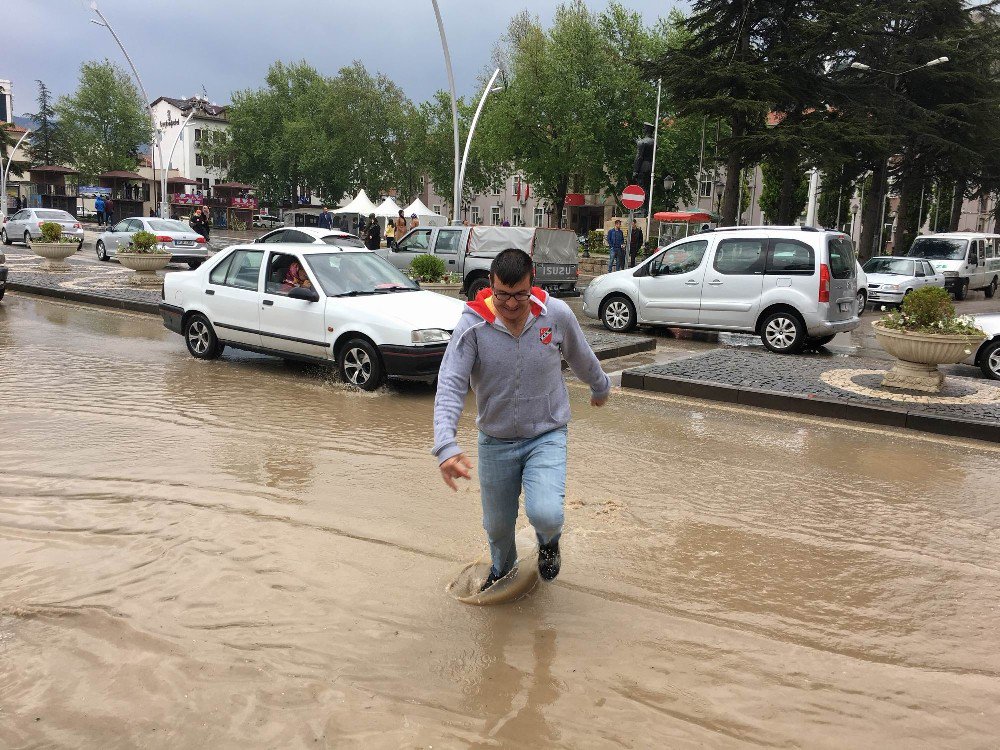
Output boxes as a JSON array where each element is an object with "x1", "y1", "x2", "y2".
[{"x1": 160, "y1": 243, "x2": 463, "y2": 390}]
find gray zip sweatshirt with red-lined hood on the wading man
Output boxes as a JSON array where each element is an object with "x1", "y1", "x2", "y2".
[{"x1": 432, "y1": 287, "x2": 611, "y2": 463}]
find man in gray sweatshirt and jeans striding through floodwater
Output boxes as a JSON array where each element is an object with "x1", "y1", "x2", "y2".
[{"x1": 433, "y1": 248, "x2": 611, "y2": 591}]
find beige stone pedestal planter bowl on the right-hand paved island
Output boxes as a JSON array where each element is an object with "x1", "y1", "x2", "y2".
[{"x1": 872, "y1": 323, "x2": 983, "y2": 393}]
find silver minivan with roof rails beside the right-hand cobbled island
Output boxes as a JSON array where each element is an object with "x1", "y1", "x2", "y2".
[{"x1": 583, "y1": 227, "x2": 860, "y2": 354}]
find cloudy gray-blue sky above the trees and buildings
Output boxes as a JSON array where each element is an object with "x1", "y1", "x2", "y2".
[{"x1": 0, "y1": 0, "x2": 689, "y2": 115}]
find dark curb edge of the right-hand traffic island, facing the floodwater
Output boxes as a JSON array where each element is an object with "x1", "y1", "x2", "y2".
[{"x1": 622, "y1": 371, "x2": 1000, "y2": 443}]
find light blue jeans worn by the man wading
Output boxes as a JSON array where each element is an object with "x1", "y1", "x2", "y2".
[{"x1": 479, "y1": 427, "x2": 567, "y2": 576}]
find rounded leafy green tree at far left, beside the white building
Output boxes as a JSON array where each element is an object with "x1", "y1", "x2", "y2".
[{"x1": 55, "y1": 60, "x2": 152, "y2": 178}]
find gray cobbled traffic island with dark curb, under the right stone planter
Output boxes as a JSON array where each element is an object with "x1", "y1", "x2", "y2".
[{"x1": 622, "y1": 349, "x2": 1000, "y2": 442}]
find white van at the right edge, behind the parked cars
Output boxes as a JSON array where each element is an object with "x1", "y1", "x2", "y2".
[{"x1": 906, "y1": 232, "x2": 1000, "y2": 300}]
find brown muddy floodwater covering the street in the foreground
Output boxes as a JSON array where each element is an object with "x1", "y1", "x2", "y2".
[{"x1": 0, "y1": 295, "x2": 1000, "y2": 748}]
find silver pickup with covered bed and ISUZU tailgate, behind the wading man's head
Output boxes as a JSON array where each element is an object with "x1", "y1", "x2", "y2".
[{"x1": 378, "y1": 226, "x2": 580, "y2": 300}]
